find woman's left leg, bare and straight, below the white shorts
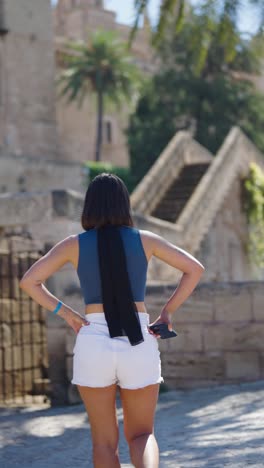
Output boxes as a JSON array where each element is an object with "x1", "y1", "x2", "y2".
[{"x1": 78, "y1": 384, "x2": 121, "y2": 468}]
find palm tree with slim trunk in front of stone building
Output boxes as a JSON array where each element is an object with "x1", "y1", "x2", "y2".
[{"x1": 58, "y1": 31, "x2": 138, "y2": 161}]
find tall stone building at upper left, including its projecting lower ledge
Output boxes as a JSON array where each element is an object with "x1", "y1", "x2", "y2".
[{"x1": 0, "y1": 0, "x2": 85, "y2": 193}]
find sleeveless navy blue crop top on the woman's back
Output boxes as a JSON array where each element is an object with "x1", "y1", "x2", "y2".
[{"x1": 77, "y1": 226, "x2": 148, "y2": 304}]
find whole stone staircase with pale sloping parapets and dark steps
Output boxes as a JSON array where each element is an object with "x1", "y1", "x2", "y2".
[{"x1": 130, "y1": 127, "x2": 264, "y2": 255}]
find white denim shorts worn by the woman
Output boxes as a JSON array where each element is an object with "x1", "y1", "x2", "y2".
[{"x1": 71, "y1": 312, "x2": 164, "y2": 389}]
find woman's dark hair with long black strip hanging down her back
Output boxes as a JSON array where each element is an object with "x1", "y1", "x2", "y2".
[{"x1": 81, "y1": 172, "x2": 144, "y2": 346}]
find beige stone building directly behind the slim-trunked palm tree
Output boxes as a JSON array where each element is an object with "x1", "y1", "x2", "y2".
[{"x1": 53, "y1": 0, "x2": 154, "y2": 167}]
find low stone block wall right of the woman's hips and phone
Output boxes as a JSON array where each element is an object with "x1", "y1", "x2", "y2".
[{"x1": 146, "y1": 282, "x2": 264, "y2": 388}]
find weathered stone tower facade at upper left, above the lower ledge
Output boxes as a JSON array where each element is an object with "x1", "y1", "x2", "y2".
[{"x1": 0, "y1": 0, "x2": 58, "y2": 159}]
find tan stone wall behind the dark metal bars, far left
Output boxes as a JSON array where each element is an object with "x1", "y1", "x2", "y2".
[{"x1": 0, "y1": 251, "x2": 49, "y2": 402}]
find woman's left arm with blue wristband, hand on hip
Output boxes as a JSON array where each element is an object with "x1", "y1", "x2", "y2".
[{"x1": 19, "y1": 235, "x2": 87, "y2": 332}]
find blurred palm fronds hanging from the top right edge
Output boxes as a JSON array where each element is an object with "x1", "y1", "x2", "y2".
[{"x1": 129, "y1": 0, "x2": 264, "y2": 72}]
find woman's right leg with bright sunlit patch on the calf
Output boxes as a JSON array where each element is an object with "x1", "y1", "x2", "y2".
[{"x1": 120, "y1": 384, "x2": 159, "y2": 468}]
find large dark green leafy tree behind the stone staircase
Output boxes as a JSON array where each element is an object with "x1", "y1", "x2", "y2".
[{"x1": 127, "y1": 5, "x2": 264, "y2": 182}]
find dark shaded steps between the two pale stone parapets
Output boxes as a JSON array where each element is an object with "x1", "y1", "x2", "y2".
[{"x1": 151, "y1": 163, "x2": 209, "y2": 223}]
